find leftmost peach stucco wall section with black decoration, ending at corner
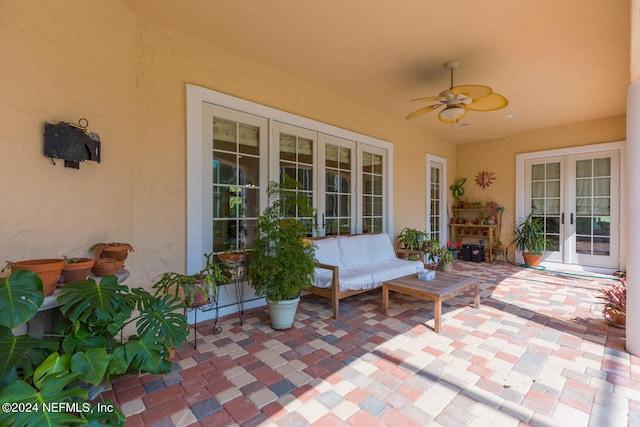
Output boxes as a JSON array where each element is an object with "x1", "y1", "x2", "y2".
[{"x1": 0, "y1": 0, "x2": 137, "y2": 266}]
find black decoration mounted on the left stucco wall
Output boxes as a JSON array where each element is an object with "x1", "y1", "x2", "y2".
[{"x1": 44, "y1": 119, "x2": 100, "y2": 169}]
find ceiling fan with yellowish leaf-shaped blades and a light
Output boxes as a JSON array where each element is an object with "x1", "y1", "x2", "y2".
[{"x1": 406, "y1": 61, "x2": 509, "y2": 123}]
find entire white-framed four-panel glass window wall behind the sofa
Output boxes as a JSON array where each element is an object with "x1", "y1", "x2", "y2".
[{"x1": 187, "y1": 85, "x2": 393, "y2": 271}]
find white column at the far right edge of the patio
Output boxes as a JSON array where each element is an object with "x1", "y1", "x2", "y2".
[{"x1": 624, "y1": 81, "x2": 640, "y2": 356}]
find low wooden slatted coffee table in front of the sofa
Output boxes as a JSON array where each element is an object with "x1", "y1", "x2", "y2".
[{"x1": 382, "y1": 271, "x2": 479, "y2": 332}]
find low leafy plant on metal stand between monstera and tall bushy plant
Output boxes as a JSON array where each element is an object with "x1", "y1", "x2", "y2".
[{"x1": 151, "y1": 252, "x2": 230, "y2": 307}]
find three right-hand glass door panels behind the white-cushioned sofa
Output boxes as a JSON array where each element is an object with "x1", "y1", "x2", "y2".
[{"x1": 270, "y1": 122, "x2": 380, "y2": 236}]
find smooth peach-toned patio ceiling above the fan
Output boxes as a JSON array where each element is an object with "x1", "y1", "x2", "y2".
[{"x1": 124, "y1": 0, "x2": 631, "y2": 143}]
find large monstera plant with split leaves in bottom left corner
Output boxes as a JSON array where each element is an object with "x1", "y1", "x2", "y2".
[{"x1": 0, "y1": 270, "x2": 188, "y2": 426}]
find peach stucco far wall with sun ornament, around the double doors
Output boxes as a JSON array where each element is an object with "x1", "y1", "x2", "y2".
[{"x1": 456, "y1": 117, "x2": 626, "y2": 249}]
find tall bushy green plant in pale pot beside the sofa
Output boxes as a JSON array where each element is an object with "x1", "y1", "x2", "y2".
[{"x1": 246, "y1": 175, "x2": 316, "y2": 329}]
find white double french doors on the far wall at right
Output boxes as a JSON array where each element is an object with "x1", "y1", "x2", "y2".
[{"x1": 524, "y1": 150, "x2": 620, "y2": 268}]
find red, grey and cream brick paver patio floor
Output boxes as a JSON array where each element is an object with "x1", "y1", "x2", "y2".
[{"x1": 105, "y1": 262, "x2": 640, "y2": 427}]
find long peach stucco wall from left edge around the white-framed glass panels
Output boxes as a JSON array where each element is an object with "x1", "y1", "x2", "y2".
[{"x1": 0, "y1": 0, "x2": 456, "y2": 286}]
